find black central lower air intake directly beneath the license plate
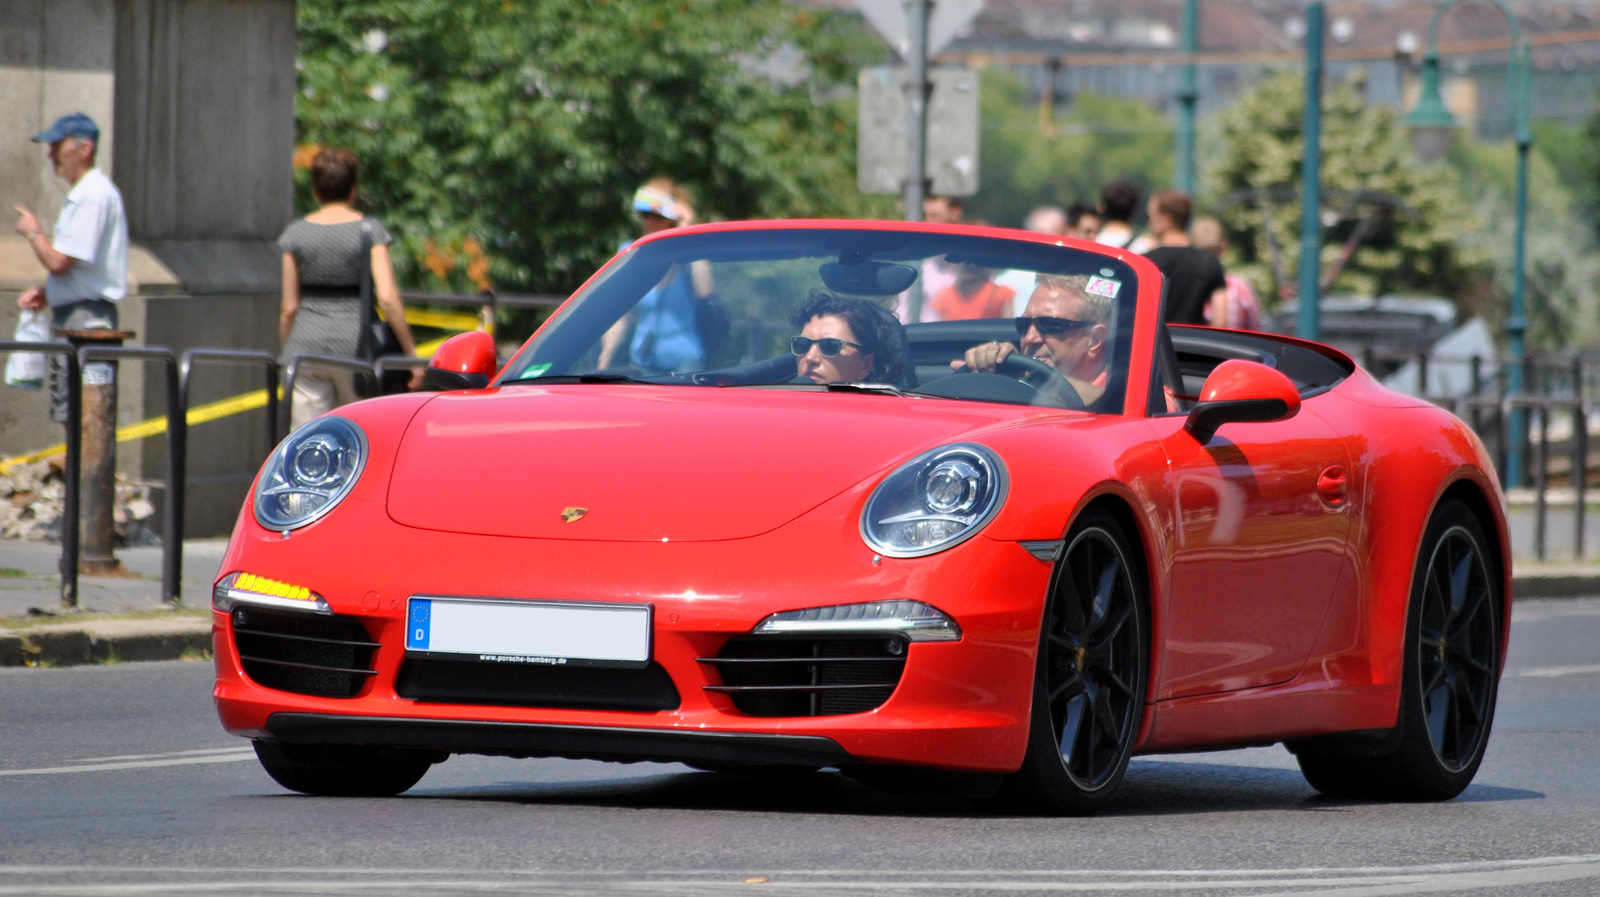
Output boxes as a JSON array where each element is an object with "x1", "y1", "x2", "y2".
[{"x1": 395, "y1": 657, "x2": 682, "y2": 713}]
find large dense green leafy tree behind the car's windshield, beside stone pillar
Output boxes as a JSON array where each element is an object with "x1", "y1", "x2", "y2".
[{"x1": 296, "y1": 0, "x2": 893, "y2": 293}]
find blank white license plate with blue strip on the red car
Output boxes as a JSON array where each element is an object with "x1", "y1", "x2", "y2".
[{"x1": 405, "y1": 596, "x2": 650, "y2": 667}]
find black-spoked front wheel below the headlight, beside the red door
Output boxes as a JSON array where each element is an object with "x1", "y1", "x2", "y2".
[{"x1": 1000, "y1": 508, "x2": 1150, "y2": 815}]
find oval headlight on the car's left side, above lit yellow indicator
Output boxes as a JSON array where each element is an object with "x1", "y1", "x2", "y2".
[{"x1": 254, "y1": 417, "x2": 366, "y2": 531}]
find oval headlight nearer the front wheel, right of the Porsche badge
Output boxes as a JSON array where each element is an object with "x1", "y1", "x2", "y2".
[{"x1": 861, "y1": 443, "x2": 1006, "y2": 558}]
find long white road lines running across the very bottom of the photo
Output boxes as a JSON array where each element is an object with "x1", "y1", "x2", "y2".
[{"x1": 0, "y1": 855, "x2": 1600, "y2": 897}]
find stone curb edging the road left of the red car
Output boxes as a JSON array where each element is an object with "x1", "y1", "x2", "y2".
[{"x1": 0, "y1": 619, "x2": 211, "y2": 667}]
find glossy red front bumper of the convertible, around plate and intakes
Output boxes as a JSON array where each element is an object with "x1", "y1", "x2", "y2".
[{"x1": 213, "y1": 497, "x2": 1050, "y2": 772}]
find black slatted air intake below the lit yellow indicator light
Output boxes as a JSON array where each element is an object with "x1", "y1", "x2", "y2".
[{"x1": 232, "y1": 608, "x2": 378, "y2": 697}]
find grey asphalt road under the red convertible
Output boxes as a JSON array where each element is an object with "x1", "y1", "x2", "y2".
[{"x1": 0, "y1": 598, "x2": 1600, "y2": 897}]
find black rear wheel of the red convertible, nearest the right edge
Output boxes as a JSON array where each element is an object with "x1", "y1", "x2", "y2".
[{"x1": 1296, "y1": 499, "x2": 1504, "y2": 801}]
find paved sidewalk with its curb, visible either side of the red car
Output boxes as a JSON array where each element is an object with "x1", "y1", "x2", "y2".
[{"x1": 0, "y1": 539, "x2": 1600, "y2": 667}]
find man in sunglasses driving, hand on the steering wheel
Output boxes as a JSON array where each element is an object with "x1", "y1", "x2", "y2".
[{"x1": 950, "y1": 273, "x2": 1112, "y2": 405}]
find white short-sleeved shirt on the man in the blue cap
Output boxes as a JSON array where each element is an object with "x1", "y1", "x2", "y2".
[{"x1": 45, "y1": 168, "x2": 128, "y2": 305}]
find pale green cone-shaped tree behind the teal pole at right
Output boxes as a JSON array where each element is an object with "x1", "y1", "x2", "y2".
[{"x1": 1210, "y1": 72, "x2": 1483, "y2": 306}]
